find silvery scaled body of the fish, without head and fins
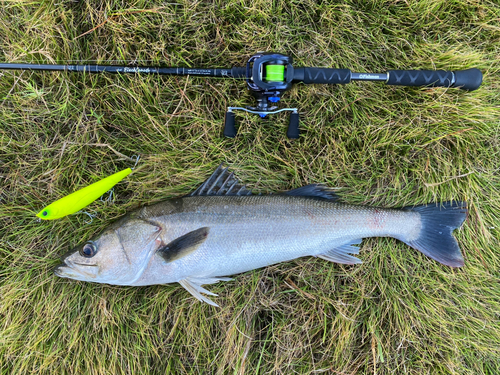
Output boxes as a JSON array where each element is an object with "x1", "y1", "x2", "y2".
[{"x1": 130, "y1": 195, "x2": 420, "y2": 285}]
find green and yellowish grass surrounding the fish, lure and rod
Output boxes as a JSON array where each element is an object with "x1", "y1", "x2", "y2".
[{"x1": 0, "y1": 0, "x2": 500, "y2": 374}]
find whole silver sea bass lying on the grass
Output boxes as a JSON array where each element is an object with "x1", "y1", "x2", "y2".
[{"x1": 54, "y1": 166, "x2": 467, "y2": 306}]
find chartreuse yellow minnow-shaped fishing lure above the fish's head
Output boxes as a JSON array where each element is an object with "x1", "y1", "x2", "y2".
[{"x1": 36, "y1": 168, "x2": 132, "y2": 220}]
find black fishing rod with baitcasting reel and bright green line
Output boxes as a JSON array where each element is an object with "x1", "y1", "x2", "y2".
[{"x1": 0, "y1": 52, "x2": 483, "y2": 139}]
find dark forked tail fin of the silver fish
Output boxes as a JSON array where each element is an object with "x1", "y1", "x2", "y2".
[{"x1": 403, "y1": 202, "x2": 467, "y2": 267}]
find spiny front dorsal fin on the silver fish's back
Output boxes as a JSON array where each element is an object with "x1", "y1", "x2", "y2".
[{"x1": 190, "y1": 164, "x2": 252, "y2": 197}]
